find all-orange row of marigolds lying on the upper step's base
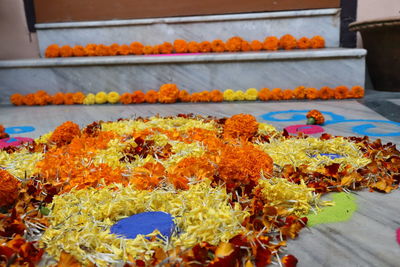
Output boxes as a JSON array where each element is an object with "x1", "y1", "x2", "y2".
[{"x1": 45, "y1": 34, "x2": 325, "y2": 58}]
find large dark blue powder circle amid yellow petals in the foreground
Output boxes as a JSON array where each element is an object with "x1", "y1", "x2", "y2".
[{"x1": 110, "y1": 211, "x2": 175, "y2": 239}]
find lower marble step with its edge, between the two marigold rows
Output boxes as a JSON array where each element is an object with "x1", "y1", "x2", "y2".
[{"x1": 0, "y1": 48, "x2": 366, "y2": 103}]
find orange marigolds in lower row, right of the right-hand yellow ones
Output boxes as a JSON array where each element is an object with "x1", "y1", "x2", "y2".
[{"x1": 258, "y1": 85, "x2": 365, "y2": 101}]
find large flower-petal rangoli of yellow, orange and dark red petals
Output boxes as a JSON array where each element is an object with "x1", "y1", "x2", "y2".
[{"x1": 0, "y1": 114, "x2": 400, "y2": 266}]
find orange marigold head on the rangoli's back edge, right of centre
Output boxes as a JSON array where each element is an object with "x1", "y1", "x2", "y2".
[{"x1": 224, "y1": 114, "x2": 258, "y2": 140}]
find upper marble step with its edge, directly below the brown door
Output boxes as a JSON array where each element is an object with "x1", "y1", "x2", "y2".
[{"x1": 36, "y1": 8, "x2": 340, "y2": 55}]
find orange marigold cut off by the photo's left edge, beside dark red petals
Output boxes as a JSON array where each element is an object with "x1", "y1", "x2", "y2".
[{"x1": 0, "y1": 168, "x2": 20, "y2": 207}]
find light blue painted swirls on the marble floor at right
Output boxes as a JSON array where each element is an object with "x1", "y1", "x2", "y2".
[{"x1": 261, "y1": 110, "x2": 400, "y2": 137}]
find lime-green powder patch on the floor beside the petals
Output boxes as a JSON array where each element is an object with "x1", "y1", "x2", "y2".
[{"x1": 307, "y1": 193, "x2": 357, "y2": 227}]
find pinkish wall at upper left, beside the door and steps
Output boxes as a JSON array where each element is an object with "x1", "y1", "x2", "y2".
[{"x1": 0, "y1": 0, "x2": 39, "y2": 60}]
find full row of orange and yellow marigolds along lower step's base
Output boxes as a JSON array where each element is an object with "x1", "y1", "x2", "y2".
[{"x1": 10, "y1": 84, "x2": 365, "y2": 106}]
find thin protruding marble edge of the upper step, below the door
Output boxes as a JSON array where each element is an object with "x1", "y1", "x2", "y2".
[{"x1": 35, "y1": 8, "x2": 340, "y2": 30}]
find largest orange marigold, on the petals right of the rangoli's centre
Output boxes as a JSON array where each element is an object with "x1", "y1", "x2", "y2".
[{"x1": 218, "y1": 143, "x2": 273, "y2": 188}]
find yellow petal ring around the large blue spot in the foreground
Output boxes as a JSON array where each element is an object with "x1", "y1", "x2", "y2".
[{"x1": 41, "y1": 181, "x2": 248, "y2": 266}]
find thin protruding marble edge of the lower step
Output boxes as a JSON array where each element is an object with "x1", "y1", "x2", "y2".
[{"x1": 0, "y1": 48, "x2": 367, "y2": 69}]
